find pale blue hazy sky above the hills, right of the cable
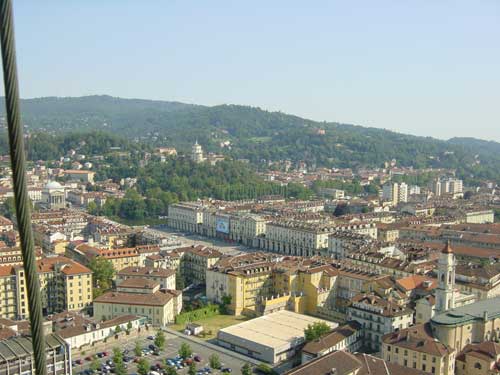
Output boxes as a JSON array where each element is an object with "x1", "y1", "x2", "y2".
[{"x1": 4, "y1": 0, "x2": 500, "y2": 141}]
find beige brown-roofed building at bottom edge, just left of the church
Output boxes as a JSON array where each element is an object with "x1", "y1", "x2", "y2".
[{"x1": 382, "y1": 323, "x2": 456, "y2": 375}]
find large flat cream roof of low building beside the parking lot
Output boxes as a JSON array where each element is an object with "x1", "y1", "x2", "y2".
[{"x1": 219, "y1": 310, "x2": 338, "y2": 348}]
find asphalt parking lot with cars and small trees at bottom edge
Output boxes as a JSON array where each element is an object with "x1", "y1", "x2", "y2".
[{"x1": 73, "y1": 333, "x2": 252, "y2": 375}]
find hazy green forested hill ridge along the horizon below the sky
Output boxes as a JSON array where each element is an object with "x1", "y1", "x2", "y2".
[{"x1": 0, "y1": 96, "x2": 500, "y2": 180}]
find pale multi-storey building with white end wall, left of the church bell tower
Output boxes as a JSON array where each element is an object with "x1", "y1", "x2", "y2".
[{"x1": 347, "y1": 293, "x2": 413, "y2": 351}]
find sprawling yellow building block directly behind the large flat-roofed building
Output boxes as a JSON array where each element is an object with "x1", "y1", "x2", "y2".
[{"x1": 206, "y1": 253, "x2": 338, "y2": 315}]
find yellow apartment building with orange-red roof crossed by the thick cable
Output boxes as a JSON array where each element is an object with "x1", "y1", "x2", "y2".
[{"x1": 0, "y1": 256, "x2": 92, "y2": 319}]
